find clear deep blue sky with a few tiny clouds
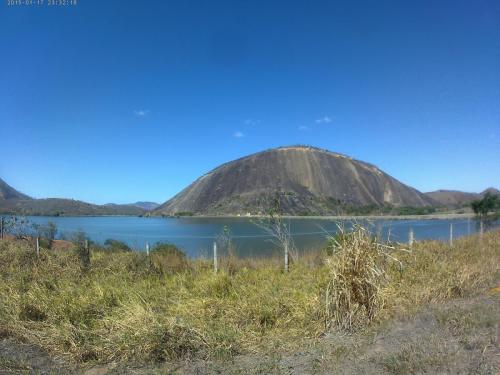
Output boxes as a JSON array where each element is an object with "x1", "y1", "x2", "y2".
[{"x1": 0, "y1": 0, "x2": 500, "y2": 203}]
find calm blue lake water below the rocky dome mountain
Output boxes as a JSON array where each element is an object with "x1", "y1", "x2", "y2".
[{"x1": 6, "y1": 216, "x2": 500, "y2": 257}]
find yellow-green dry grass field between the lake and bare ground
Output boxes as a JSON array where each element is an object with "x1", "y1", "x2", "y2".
[{"x1": 0, "y1": 228, "x2": 500, "y2": 363}]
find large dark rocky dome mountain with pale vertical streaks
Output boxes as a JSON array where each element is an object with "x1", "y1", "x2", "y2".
[{"x1": 153, "y1": 146, "x2": 435, "y2": 215}]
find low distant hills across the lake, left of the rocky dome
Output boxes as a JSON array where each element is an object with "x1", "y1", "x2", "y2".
[{"x1": 0, "y1": 179, "x2": 146, "y2": 216}]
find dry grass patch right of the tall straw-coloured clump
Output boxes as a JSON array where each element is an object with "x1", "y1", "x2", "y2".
[{"x1": 384, "y1": 230, "x2": 500, "y2": 313}]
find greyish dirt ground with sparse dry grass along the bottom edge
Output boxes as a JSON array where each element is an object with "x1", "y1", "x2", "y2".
[{"x1": 0, "y1": 296, "x2": 500, "y2": 375}]
